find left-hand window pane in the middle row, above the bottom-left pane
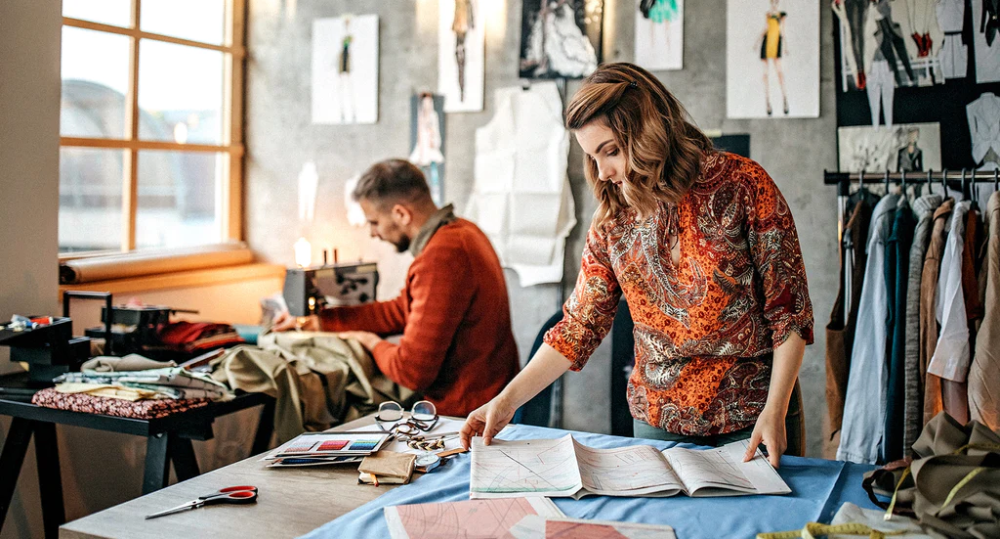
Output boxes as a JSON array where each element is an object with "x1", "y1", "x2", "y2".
[{"x1": 59, "y1": 26, "x2": 129, "y2": 138}]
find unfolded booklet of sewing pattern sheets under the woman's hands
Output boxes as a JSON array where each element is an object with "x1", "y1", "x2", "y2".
[{"x1": 470, "y1": 434, "x2": 791, "y2": 499}]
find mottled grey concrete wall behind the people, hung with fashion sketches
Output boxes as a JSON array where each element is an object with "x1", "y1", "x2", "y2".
[{"x1": 246, "y1": 0, "x2": 837, "y2": 455}]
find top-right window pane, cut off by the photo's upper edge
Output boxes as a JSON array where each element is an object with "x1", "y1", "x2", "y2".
[{"x1": 139, "y1": 0, "x2": 226, "y2": 45}]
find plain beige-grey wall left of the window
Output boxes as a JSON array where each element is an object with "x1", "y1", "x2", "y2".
[{"x1": 0, "y1": 0, "x2": 62, "y2": 537}]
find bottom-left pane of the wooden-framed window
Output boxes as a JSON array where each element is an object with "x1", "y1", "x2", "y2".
[{"x1": 59, "y1": 148, "x2": 125, "y2": 253}]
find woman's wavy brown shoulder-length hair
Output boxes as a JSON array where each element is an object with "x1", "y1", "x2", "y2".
[{"x1": 566, "y1": 63, "x2": 712, "y2": 226}]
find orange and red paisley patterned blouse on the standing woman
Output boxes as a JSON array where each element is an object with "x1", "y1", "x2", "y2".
[{"x1": 545, "y1": 152, "x2": 813, "y2": 436}]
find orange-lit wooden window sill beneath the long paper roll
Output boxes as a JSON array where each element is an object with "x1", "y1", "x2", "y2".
[{"x1": 59, "y1": 263, "x2": 285, "y2": 301}]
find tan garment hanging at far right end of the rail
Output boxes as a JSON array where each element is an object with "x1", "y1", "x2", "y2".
[{"x1": 968, "y1": 193, "x2": 1000, "y2": 430}]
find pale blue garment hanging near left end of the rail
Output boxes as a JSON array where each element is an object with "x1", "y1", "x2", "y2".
[{"x1": 837, "y1": 194, "x2": 899, "y2": 464}]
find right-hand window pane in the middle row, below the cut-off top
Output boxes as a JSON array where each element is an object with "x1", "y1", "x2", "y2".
[{"x1": 139, "y1": 39, "x2": 224, "y2": 144}]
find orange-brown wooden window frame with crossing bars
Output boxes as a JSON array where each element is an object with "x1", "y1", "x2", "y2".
[{"x1": 59, "y1": 0, "x2": 247, "y2": 261}]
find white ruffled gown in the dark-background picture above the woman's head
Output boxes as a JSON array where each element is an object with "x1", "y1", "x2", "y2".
[{"x1": 521, "y1": 0, "x2": 597, "y2": 77}]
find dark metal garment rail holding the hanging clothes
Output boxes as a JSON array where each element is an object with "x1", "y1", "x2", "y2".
[{"x1": 823, "y1": 168, "x2": 1000, "y2": 319}]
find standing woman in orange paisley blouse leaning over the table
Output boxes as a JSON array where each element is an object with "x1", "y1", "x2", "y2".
[{"x1": 461, "y1": 64, "x2": 813, "y2": 466}]
